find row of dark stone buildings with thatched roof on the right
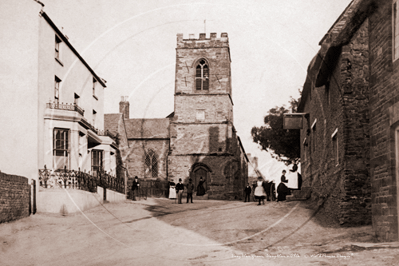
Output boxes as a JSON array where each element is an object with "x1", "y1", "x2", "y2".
[{"x1": 298, "y1": 0, "x2": 399, "y2": 241}]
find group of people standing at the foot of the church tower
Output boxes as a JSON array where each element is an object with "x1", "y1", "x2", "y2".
[{"x1": 169, "y1": 177, "x2": 205, "y2": 204}]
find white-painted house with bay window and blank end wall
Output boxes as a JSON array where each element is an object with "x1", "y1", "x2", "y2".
[{"x1": 0, "y1": 0, "x2": 117, "y2": 191}]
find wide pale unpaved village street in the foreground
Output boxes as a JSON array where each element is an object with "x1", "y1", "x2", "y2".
[{"x1": 0, "y1": 198, "x2": 399, "y2": 265}]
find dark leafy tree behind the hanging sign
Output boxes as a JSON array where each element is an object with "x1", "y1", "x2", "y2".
[{"x1": 251, "y1": 97, "x2": 301, "y2": 163}]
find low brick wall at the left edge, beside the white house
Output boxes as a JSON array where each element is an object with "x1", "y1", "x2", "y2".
[{"x1": 0, "y1": 172, "x2": 31, "y2": 223}]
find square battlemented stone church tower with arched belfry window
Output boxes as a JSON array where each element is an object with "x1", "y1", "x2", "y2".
[{"x1": 168, "y1": 33, "x2": 242, "y2": 198}]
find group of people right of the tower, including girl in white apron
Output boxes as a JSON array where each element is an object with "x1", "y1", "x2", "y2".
[{"x1": 244, "y1": 170, "x2": 291, "y2": 205}]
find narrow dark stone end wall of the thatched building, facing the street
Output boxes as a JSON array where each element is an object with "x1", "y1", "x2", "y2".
[{"x1": 340, "y1": 20, "x2": 371, "y2": 225}]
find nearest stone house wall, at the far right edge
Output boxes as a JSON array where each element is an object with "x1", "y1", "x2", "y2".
[{"x1": 369, "y1": 1, "x2": 399, "y2": 241}]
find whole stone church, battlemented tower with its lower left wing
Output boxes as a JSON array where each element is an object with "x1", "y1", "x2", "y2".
[{"x1": 106, "y1": 33, "x2": 248, "y2": 199}]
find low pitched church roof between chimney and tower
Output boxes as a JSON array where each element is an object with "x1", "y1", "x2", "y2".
[{"x1": 125, "y1": 118, "x2": 170, "y2": 139}]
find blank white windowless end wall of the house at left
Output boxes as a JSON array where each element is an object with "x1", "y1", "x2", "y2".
[{"x1": 0, "y1": 0, "x2": 42, "y2": 179}]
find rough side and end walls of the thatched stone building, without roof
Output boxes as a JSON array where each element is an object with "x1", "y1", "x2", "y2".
[{"x1": 301, "y1": 20, "x2": 371, "y2": 225}]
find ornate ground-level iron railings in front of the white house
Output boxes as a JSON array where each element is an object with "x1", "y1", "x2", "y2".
[{"x1": 39, "y1": 166, "x2": 125, "y2": 194}]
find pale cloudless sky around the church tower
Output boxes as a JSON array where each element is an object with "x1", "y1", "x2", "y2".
[{"x1": 41, "y1": 0, "x2": 351, "y2": 175}]
